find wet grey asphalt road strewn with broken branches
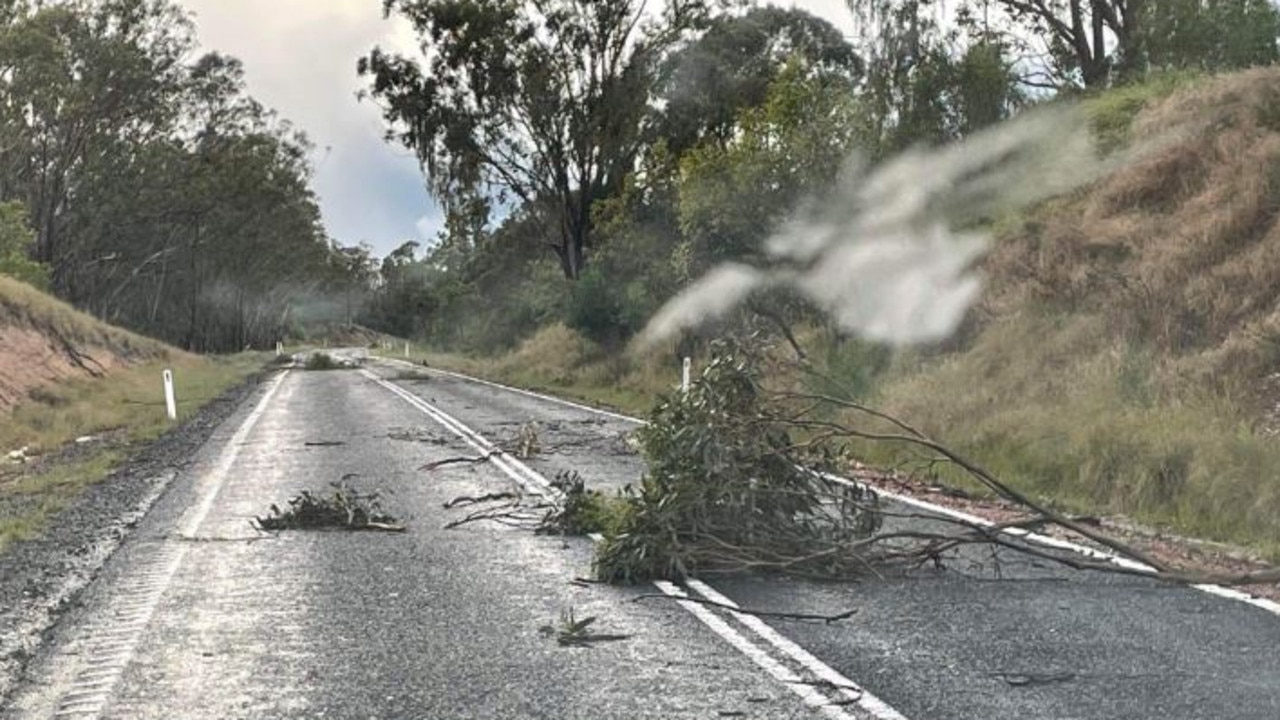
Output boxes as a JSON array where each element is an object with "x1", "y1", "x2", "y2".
[{"x1": 3, "y1": 353, "x2": 1280, "y2": 720}]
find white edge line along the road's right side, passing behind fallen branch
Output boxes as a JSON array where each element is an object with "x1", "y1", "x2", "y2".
[{"x1": 404, "y1": 360, "x2": 1280, "y2": 615}]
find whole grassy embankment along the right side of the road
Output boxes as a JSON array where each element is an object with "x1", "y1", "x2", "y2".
[{"x1": 399, "y1": 69, "x2": 1280, "y2": 559}]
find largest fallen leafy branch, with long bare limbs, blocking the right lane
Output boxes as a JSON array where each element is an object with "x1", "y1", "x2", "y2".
[{"x1": 596, "y1": 335, "x2": 1280, "y2": 585}]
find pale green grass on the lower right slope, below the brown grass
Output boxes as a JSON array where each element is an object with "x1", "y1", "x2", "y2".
[{"x1": 846, "y1": 313, "x2": 1280, "y2": 559}]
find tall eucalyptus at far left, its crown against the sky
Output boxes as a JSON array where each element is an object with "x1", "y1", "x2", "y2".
[{"x1": 0, "y1": 0, "x2": 193, "y2": 285}]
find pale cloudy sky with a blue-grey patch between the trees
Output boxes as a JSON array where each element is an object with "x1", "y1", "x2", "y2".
[{"x1": 179, "y1": 0, "x2": 852, "y2": 256}]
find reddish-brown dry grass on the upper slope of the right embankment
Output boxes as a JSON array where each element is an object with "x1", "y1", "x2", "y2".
[{"x1": 983, "y1": 69, "x2": 1280, "y2": 383}]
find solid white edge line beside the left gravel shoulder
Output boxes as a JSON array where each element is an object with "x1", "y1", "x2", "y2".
[{"x1": 54, "y1": 370, "x2": 288, "y2": 719}]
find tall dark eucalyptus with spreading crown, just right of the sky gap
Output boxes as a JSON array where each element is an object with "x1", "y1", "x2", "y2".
[{"x1": 357, "y1": 0, "x2": 708, "y2": 279}]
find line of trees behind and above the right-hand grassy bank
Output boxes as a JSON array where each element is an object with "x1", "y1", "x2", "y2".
[{"x1": 358, "y1": 0, "x2": 1280, "y2": 351}]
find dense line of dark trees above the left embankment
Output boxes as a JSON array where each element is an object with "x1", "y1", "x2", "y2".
[{"x1": 0, "y1": 0, "x2": 369, "y2": 351}]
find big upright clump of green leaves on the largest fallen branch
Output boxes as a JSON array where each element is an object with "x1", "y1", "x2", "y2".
[{"x1": 595, "y1": 341, "x2": 879, "y2": 582}]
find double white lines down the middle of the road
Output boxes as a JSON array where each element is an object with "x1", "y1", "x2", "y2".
[{"x1": 361, "y1": 370, "x2": 890, "y2": 720}]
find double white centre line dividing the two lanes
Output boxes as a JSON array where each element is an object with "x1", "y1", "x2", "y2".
[{"x1": 371, "y1": 370, "x2": 906, "y2": 720}]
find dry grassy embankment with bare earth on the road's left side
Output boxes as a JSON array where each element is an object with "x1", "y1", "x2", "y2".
[{"x1": 0, "y1": 277, "x2": 269, "y2": 552}]
